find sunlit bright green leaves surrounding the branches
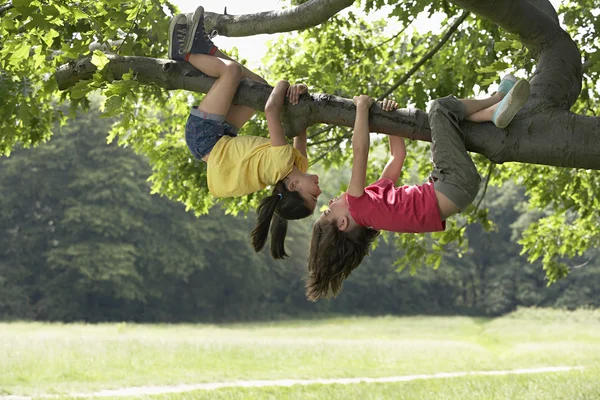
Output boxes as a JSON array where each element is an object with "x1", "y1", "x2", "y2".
[{"x1": 0, "y1": 0, "x2": 600, "y2": 285}]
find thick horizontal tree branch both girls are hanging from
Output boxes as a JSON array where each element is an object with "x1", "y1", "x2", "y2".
[{"x1": 56, "y1": 55, "x2": 600, "y2": 170}]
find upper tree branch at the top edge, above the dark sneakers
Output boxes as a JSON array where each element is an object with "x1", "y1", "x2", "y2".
[{"x1": 205, "y1": 0, "x2": 354, "y2": 37}]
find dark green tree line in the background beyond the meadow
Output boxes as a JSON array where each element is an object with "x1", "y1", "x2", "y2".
[{"x1": 0, "y1": 106, "x2": 600, "y2": 322}]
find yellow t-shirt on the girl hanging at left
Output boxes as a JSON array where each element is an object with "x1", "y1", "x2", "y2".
[{"x1": 206, "y1": 135, "x2": 308, "y2": 197}]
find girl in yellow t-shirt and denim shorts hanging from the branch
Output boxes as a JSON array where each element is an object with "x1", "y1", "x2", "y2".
[{"x1": 169, "y1": 6, "x2": 321, "y2": 259}]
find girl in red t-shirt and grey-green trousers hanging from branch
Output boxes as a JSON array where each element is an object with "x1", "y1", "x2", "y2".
[{"x1": 306, "y1": 75, "x2": 529, "y2": 301}]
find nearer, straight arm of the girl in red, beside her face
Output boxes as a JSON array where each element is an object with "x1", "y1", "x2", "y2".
[{"x1": 347, "y1": 94, "x2": 374, "y2": 197}]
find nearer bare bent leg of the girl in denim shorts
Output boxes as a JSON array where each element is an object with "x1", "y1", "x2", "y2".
[{"x1": 188, "y1": 54, "x2": 242, "y2": 115}]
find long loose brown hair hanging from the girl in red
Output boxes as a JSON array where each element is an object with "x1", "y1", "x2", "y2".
[{"x1": 306, "y1": 220, "x2": 379, "y2": 301}]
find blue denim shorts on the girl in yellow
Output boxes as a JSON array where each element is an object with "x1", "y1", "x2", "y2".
[{"x1": 185, "y1": 107, "x2": 238, "y2": 160}]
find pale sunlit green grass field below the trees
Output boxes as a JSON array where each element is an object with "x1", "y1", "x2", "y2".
[{"x1": 0, "y1": 309, "x2": 600, "y2": 400}]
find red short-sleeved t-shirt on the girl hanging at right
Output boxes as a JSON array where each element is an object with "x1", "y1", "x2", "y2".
[{"x1": 346, "y1": 178, "x2": 446, "y2": 233}]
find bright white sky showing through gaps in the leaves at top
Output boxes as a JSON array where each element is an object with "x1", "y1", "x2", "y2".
[{"x1": 172, "y1": 0, "x2": 561, "y2": 68}]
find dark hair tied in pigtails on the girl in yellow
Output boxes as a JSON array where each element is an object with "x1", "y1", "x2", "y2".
[{"x1": 252, "y1": 180, "x2": 314, "y2": 260}]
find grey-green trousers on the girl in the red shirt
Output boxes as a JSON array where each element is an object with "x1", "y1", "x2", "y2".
[{"x1": 429, "y1": 96, "x2": 481, "y2": 211}]
